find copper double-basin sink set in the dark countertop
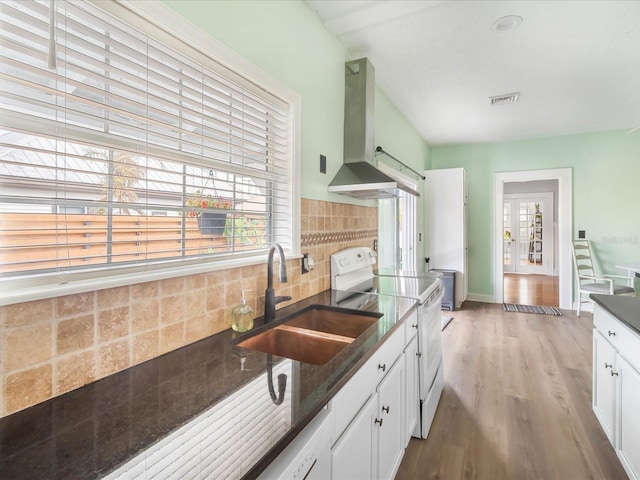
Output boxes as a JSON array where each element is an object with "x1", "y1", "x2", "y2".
[{"x1": 238, "y1": 305, "x2": 381, "y2": 365}]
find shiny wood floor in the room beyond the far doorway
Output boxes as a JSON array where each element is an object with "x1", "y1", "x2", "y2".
[{"x1": 504, "y1": 273, "x2": 560, "y2": 307}]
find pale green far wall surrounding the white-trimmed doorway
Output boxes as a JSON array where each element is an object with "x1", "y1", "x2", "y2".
[{"x1": 431, "y1": 130, "x2": 640, "y2": 295}]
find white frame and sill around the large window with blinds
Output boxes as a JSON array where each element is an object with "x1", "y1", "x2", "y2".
[{"x1": 0, "y1": 0, "x2": 301, "y2": 305}]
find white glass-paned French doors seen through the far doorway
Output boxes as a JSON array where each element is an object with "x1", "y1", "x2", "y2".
[{"x1": 503, "y1": 194, "x2": 553, "y2": 275}]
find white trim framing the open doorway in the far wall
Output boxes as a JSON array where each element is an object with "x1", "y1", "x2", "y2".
[{"x1": 493, "y1": 168, "x2": 573, "y2": 310}]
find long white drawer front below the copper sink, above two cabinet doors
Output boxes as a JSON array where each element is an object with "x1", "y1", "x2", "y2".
[{"x1": 331, "y1": 328, "x2": 404, "y2": 442}]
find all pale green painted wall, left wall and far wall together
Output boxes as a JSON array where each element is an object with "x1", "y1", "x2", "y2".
[{"x1": 156, "y1": 0, "x2": 640, "y2": 304}]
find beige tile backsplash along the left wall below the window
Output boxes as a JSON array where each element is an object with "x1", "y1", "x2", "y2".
[{"x1": 0, "y1": 199, "x2": 377, "y2": 417}]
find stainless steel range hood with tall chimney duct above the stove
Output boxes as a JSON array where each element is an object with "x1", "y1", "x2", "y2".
[{"x1": 329, "y1": 58, "x2": 420, "y2": 199}]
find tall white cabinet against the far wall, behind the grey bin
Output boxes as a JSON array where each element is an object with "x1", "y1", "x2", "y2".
[{"x1": 424, "y1": 168, "x2": 468, "y2": 308}]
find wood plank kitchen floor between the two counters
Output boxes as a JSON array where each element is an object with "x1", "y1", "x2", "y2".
[{"x1": 396, "y1": 302, "x2": 627, "y2": 480}]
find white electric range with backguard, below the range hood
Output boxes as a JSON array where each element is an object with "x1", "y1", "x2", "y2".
[{"x1": 331, "y1": 247, "x2": 444, "y2": 438}]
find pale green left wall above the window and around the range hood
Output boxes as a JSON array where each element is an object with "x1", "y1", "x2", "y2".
[{"x1": 160, "y1": 0, "x2": 430, "y2": 204}]
